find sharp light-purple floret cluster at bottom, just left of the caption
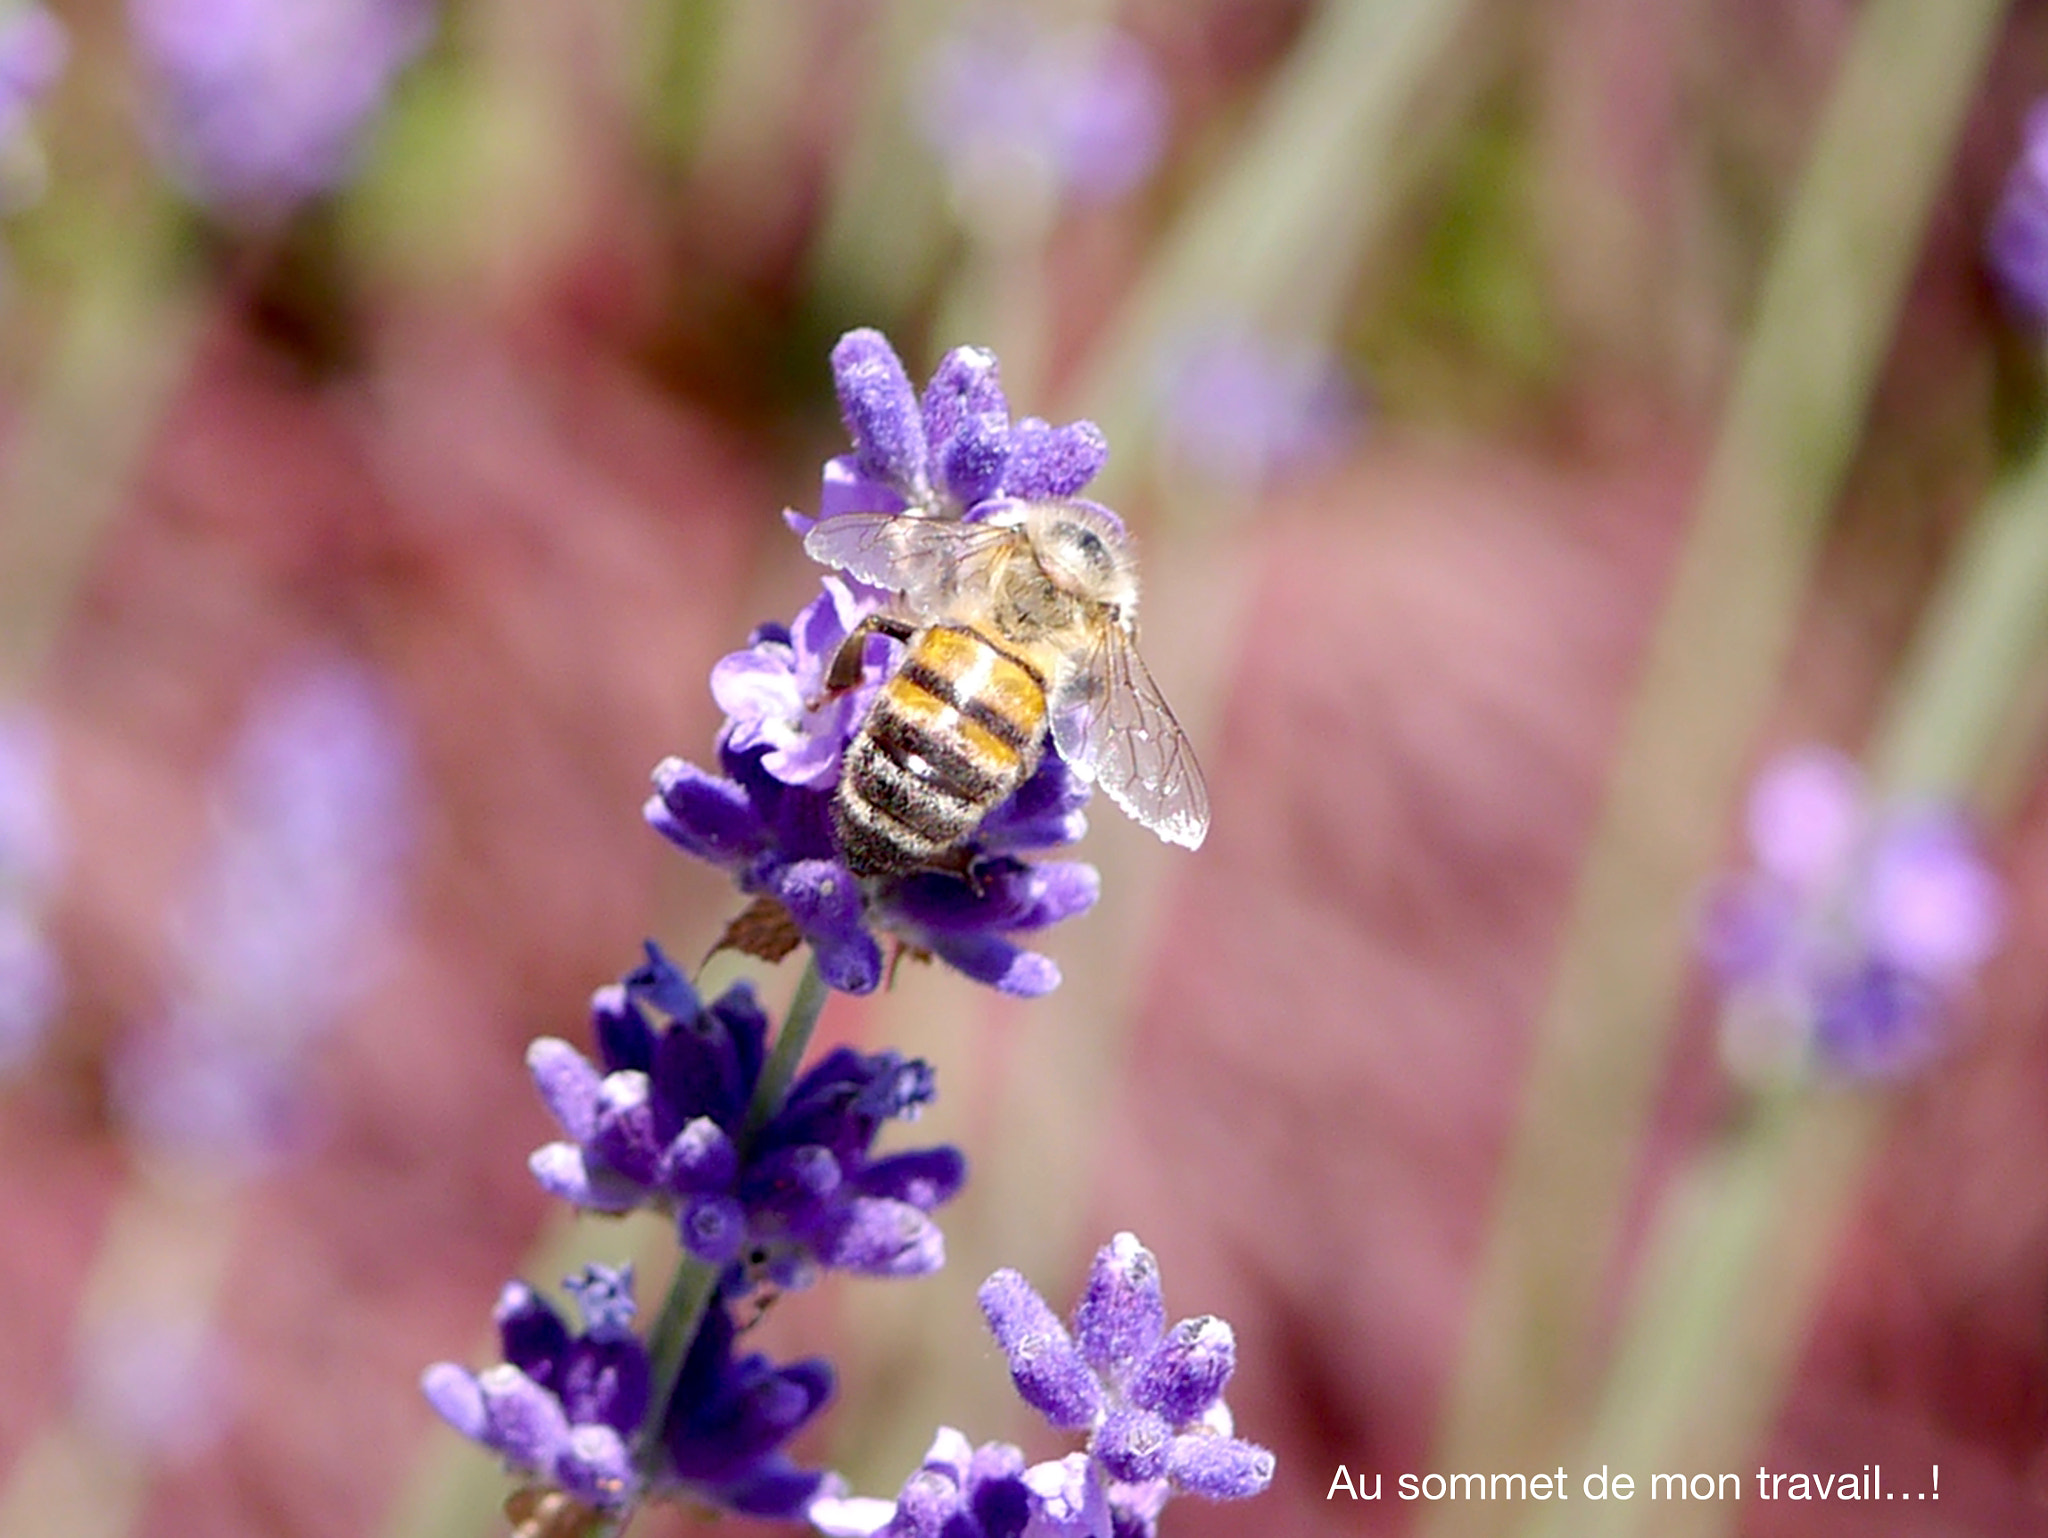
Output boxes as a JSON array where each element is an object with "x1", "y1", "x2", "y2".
[{"x1": 981, "y1": 1233, "x2": 1274, "y2": 1536}]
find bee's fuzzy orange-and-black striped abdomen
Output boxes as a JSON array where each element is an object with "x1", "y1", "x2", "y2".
[{"x1": 831, "y1": 625, "x2": 1044, "y2": 877}]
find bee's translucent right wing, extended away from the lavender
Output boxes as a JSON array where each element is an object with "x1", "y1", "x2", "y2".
[{"x1": 1049, "y1": 627, "x2": 1208, "y2": 850}]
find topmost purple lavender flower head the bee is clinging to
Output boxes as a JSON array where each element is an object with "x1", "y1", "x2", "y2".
[{"x1": 647, "y1": 330, "x2": 1108, "y2": 997}]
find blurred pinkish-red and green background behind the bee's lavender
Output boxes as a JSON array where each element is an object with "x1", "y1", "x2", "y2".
[{"x1": 0, "y1": 0, "x2": 2048, "y2": 1538}]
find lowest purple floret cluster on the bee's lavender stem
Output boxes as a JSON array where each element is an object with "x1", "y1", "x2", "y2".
[{"x1": 420, "y1": 1266, "x2": 831, "y2": 1518}]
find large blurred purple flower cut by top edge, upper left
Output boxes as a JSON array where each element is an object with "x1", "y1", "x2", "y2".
[{"x1": 129, "y1": 0, "x2": 434, "y2": 219}]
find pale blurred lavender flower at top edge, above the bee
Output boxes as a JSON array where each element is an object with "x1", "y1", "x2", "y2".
[{"x1": 918, "y1": 4, "x2": 1167, "y2": 217}]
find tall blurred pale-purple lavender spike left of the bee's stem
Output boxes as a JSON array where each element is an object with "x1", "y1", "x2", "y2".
[{"x1": 115, "y1": 661, "x2": 412, "y2": 1165}]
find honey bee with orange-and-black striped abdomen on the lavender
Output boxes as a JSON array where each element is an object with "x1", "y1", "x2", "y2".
[{"x1": 803, "y1": 502, "x2": 1208, "y2": 877}]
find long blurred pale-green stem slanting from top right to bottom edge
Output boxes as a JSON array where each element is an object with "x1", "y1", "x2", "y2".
[{"x1": 1423, "y1": 0, "x2": 2005, "y2": 1538}]
